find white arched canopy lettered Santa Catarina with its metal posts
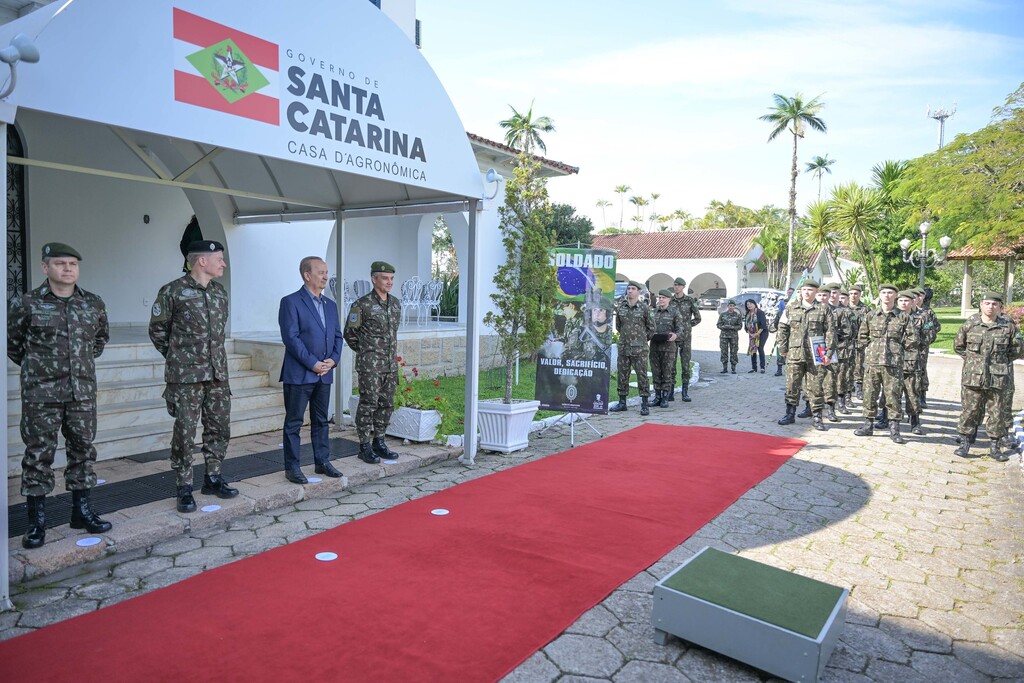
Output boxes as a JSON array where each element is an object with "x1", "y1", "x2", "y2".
[{"x1": 0, "y1": 0, "x2": 483, "y2": 608}]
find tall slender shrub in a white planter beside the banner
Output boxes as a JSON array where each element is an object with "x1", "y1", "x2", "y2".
[{"x1": 477, "y1": 154, "x2": 558, "y2": 454}]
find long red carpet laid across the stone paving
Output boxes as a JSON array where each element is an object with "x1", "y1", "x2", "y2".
[{"x1": 0, "y1": 424, "x2": 805, "y2": 682}]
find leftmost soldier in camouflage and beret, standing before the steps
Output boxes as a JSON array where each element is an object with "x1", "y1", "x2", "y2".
[{"x1": 7, "y1": 242, "x2": 112, "y2": 548}]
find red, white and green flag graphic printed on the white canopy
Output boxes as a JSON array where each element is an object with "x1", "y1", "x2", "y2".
[{"x1": 174, "y1": 7, "x2": 281, "y2": 126}]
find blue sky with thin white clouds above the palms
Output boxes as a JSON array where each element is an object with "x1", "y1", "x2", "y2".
[{"x1": 417, "y1": 0, "x2": 1024, "y2": 227}]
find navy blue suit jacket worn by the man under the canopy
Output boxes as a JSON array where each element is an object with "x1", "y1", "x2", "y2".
[{"x1": 278, "y1": 287, "x2": 344, "y2": 384}]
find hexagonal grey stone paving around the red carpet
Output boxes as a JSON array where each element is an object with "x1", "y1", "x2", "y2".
[{"x1": 0, "y1": 331, "x2": 1024, "y2": 683}]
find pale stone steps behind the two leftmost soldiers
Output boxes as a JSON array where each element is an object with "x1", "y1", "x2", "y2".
[{"x1": 7, "y1": 343, "x2": 285, "y2": 476}]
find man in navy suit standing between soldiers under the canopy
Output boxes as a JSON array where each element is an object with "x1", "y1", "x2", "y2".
[{"x1": 278, "y1": 256, "x2": 344, "y2": 484}]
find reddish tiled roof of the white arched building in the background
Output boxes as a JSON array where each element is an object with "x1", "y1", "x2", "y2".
[{"x1": 593, "y1": 227, "x2": 761, "y2": 259}]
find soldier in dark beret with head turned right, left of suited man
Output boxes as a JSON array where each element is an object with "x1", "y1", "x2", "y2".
[{"x1": 150, "y1": 240, "x2": 239, "y2": 512}]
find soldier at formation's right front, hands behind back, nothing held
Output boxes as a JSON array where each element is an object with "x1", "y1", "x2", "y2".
[{"x1": 853, "y1": 284, "x2": 918, "y2": 443}]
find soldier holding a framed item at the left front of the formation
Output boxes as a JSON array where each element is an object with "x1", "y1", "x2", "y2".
[{"x1": 778, "y1": 280, "x2": 836, "y2": 431}]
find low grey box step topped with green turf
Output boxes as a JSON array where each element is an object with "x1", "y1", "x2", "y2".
[{"x1": 651, "y1": 548, "x2": 850, "y2": 681}]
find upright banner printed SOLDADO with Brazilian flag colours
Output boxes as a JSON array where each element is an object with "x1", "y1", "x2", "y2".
[{"x1": 534, "y1": 248, "x2": 615, "y2": 414}]
